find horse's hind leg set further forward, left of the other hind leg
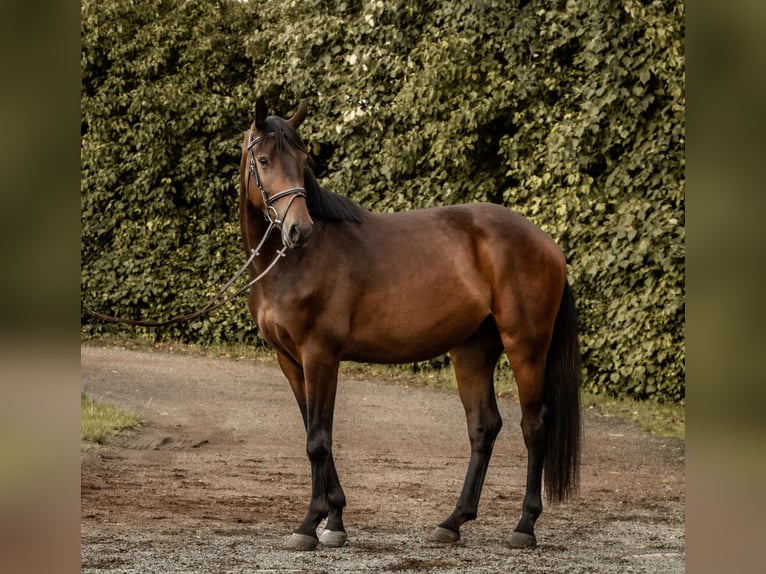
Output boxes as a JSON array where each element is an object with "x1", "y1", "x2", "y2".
[{"x1": 429, "y1": 318, "x2": 503, "y2": 543}]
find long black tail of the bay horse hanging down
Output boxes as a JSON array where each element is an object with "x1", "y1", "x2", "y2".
[{"x1": 543, "y1": 281, "x2": 582, "y2": 502}]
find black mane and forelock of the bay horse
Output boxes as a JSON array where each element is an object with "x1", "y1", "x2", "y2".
[{"x1": 260, "y1": 116, "x2": 369, "y2": 223}]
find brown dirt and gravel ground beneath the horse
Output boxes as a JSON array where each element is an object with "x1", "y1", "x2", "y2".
[{"x1": 81, "y1": 344, "x2": 685, "y2": 574}]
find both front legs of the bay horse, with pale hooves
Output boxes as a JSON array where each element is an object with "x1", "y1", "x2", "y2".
[{"x1": 280, "y1": 357, "x2": 347, "y2": 550}]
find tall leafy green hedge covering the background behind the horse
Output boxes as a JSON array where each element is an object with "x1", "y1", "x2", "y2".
[{"x1": 82, "y1": 0, "x2": 685, "y2": 401}]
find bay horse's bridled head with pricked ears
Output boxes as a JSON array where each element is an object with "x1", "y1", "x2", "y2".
[{"x1": 242, "y1": 97, "x2": 314, "y2": 248}]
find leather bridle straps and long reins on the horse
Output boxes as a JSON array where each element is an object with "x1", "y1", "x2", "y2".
[{"x1": 83, "y1": 132, "x2": 306, "y2": 327}]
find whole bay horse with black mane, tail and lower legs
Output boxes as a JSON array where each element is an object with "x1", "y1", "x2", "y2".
[{"x1": 239, "y1": 97, "x2": 581, "y2": 550}]
